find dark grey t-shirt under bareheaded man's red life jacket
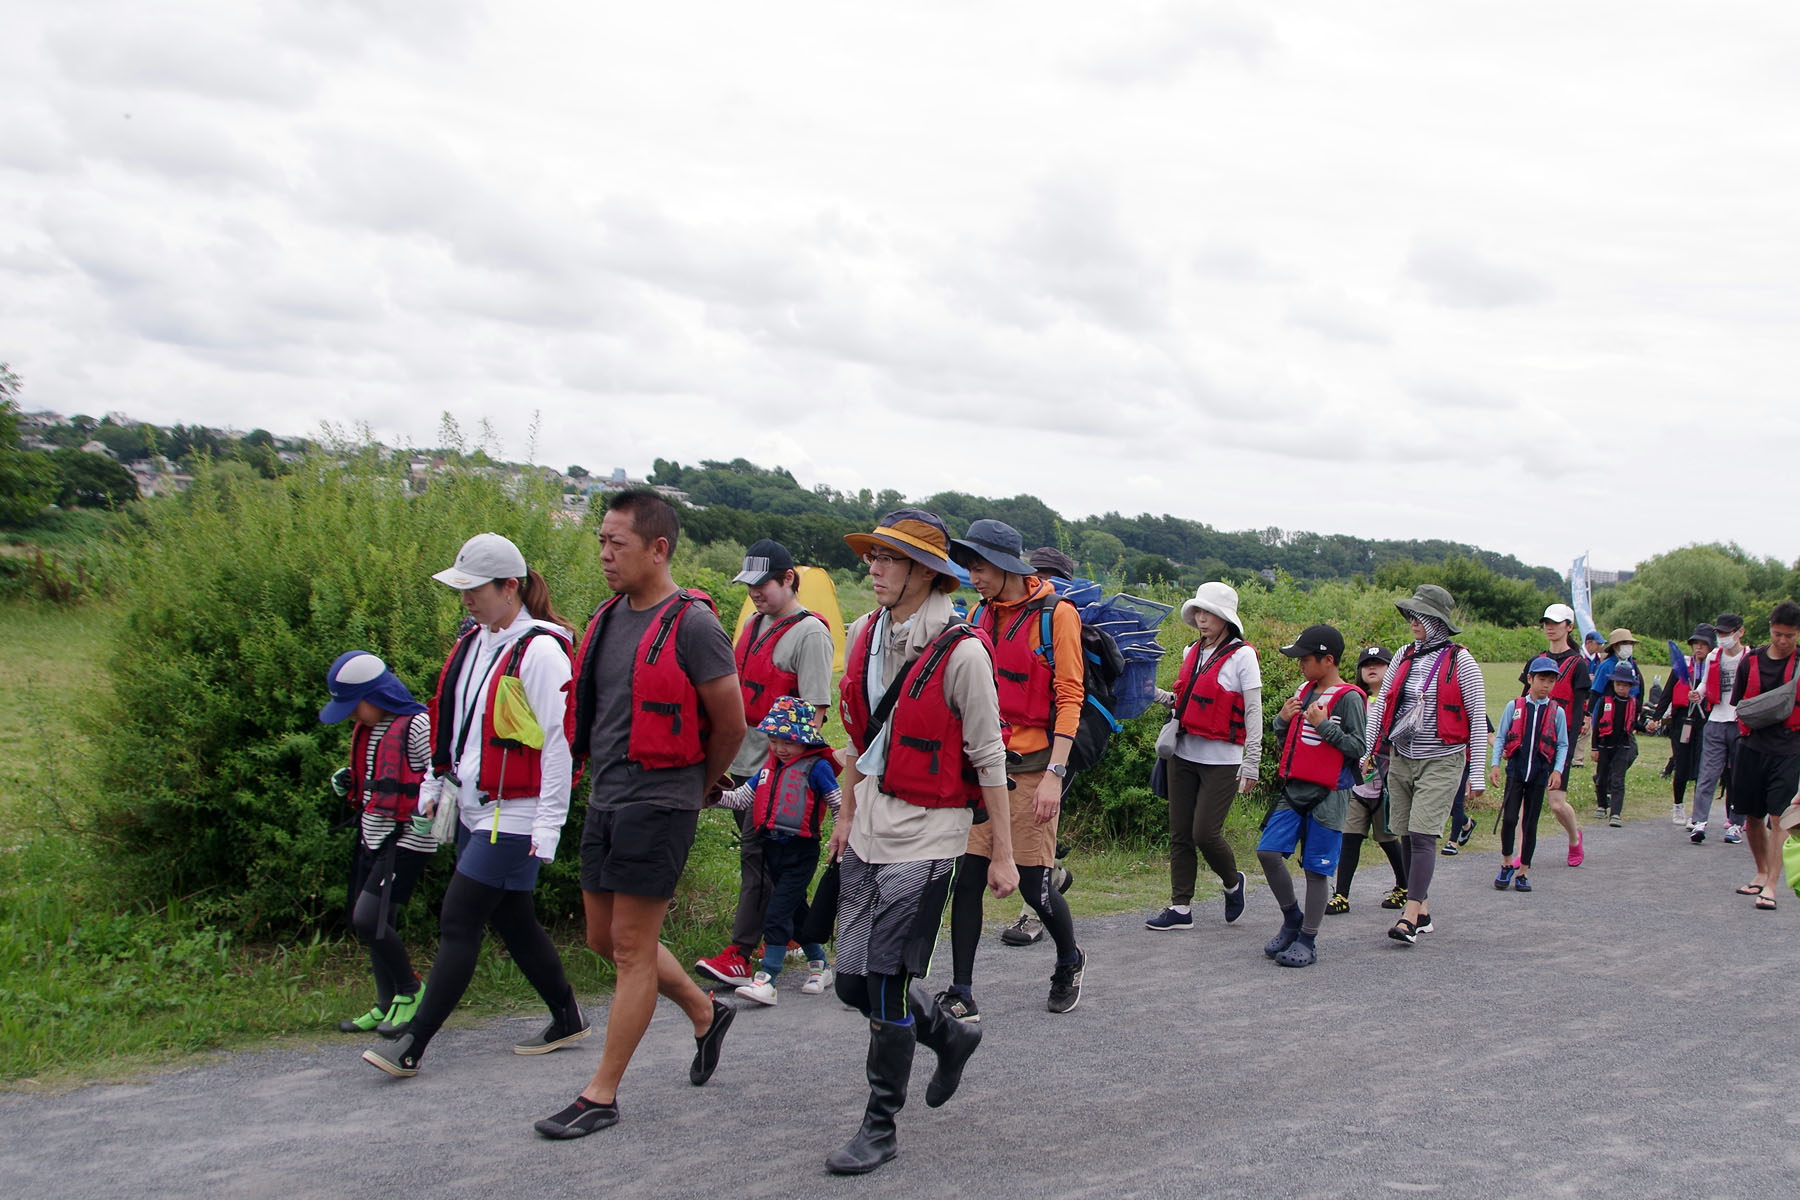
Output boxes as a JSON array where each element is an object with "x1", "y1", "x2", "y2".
[{"x1": 589, "y1": 596, "x2": 738, "y2": 811}]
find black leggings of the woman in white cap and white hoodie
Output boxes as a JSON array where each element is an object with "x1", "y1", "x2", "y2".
[{"x1": 412, "y1": 873, "x2": 572, "y2": 1051}]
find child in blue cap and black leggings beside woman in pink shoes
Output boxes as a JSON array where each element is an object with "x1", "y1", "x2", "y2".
[{"x1": 1489, "y1": 655, "x2": 1570, "y2": 892}]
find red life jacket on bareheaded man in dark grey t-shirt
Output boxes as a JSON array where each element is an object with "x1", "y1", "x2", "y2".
[{"x1": 574, "y1": 588, "x2": 718, "y2": 770}]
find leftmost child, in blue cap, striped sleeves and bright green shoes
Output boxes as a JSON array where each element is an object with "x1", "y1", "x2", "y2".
[{"x1": 319, "y1": 649, "x2": 441, "y2": 1033}]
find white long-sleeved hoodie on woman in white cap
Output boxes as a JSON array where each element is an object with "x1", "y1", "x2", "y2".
[{"x1": 437, "y1": 608, "x2": 572, "y2": 862}]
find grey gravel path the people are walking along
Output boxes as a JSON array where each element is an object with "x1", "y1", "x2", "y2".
[{"x1": 0, "y1": 820, "x2": 1800, "y2": 1200}]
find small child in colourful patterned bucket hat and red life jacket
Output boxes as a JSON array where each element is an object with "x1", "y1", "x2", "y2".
[{"x1": 702, "y1": 696, "x2": 841, "y2": 1004}]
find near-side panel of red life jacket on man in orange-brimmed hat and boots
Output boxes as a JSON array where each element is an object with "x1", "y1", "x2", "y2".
[{"x1": 880, "y1": 624, "x2": 992, "y2": 808}]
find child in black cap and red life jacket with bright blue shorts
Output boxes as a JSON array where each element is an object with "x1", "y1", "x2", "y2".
[{"x1": 1256, "y1": 624, "x2": 1368, "y2": 966}]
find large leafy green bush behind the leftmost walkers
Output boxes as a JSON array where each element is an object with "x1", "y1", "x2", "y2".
[{"x1": 95, "y1": 450, "x2": 640, "y2": 932}]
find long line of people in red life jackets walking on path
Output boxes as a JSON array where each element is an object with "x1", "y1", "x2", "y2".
[{"x1": 320, "y1": 489, "x2": 1800, "y2": 1173}]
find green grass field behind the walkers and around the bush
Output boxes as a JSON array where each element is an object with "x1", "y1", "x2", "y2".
[{"x1": 0, "y1": 596, "x2": 1667, "y2": 1088}]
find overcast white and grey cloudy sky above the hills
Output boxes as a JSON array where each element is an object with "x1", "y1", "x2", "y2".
[{"x1": 0, "y1": 0, "x2": 1800, "y2": 567}]
